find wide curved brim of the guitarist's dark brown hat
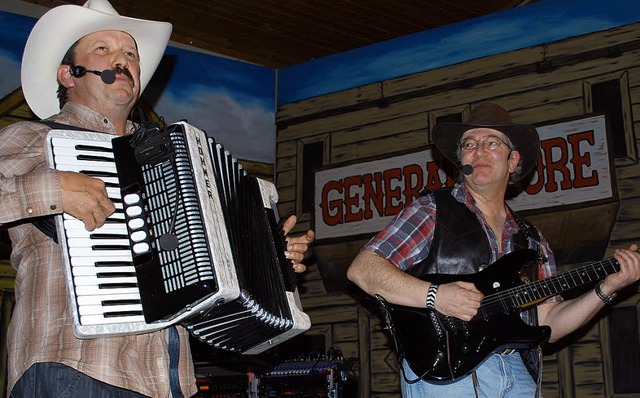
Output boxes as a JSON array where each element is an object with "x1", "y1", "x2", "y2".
[{"x1": 432, "y1": 122, "x2": 540, "y2": 178}]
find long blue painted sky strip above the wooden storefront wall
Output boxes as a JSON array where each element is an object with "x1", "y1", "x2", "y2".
[{"x1": 278, "y1": 0, "x2": 640, "y2": 104}]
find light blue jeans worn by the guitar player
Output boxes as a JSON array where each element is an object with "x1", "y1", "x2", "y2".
[{"x1": 400, "y1": 352, "x2": 536, "y2": 398}]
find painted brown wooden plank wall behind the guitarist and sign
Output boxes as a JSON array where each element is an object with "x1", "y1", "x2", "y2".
[{"x1": 276, "y1": 24, "x2": 640, "y2": 398}]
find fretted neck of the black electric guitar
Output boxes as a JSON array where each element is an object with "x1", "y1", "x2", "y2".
[{"x1": 490, "y1": 257, "x2": 620, "y2": 310}]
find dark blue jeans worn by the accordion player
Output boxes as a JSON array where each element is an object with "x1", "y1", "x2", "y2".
[{"x1": 9, "y1": 362, "x2": 145, "y2": 398}]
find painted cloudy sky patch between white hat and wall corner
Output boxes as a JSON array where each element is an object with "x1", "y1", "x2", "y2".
[{"x1": 153, "y1": 47, "x2": 276, "y2": 163}]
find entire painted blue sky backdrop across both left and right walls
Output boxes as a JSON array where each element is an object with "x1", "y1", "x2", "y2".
[{"x1": 5, "y1": 0, "x2": 640, "y2": 163}]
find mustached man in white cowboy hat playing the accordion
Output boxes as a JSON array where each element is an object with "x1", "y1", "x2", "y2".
[{"x1": 0, "y1": 0, "x2": 313, "y2": 397}]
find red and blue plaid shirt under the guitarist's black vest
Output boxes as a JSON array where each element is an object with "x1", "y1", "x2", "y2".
[{"x1": 365, "y1": 184, "x2": 561, "y2": 322}]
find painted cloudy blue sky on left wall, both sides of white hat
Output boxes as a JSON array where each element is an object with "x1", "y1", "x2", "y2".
[{"x1": 0, "y1": 11, "x2": 275, "y2": 163}]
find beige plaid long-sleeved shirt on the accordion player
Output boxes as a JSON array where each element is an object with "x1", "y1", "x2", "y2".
[{"x1": 0, "y1": 103, "x2": 196, "y2": 397}]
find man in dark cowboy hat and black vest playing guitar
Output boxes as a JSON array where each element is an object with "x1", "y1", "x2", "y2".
[{"x1": 347, "y1": 103, "x2": 640, "y2": 398}]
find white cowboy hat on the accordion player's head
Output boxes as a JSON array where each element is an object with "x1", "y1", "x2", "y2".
[{"x1": 20, "y1": 0, "x2": 172, "y2": 119}]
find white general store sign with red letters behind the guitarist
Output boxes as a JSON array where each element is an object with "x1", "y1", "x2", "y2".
[{"x1": 314, "y1": 115, "x2": 613, "y2": 239}]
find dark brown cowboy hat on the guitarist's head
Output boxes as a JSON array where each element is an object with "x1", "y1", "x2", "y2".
[{"x1": 432, "y1": 102, "x2": 540, "y2": 180}]
